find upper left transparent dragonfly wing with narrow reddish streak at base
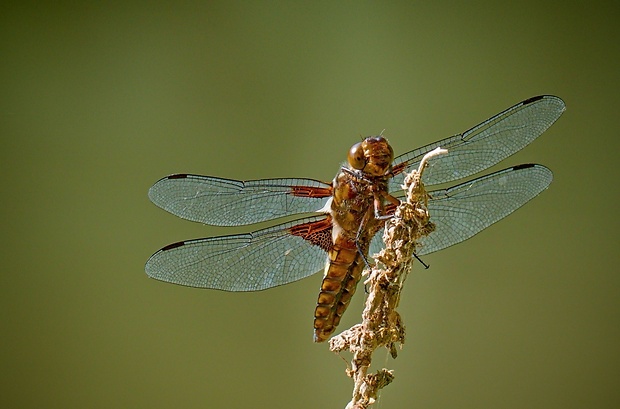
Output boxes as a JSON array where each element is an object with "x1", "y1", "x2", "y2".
[{"x1": 149, "y1": 174, "x2": 331, "y2": 226}]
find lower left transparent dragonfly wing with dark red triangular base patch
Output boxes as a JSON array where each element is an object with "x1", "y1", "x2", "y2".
[{"x1": 145, "y1": 216, "x2": 331, "y2": 291}]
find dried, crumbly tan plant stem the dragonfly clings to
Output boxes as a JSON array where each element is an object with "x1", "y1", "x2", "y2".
[{"x1": 329, "y1": 148, "x2": 447, "y2": 409}]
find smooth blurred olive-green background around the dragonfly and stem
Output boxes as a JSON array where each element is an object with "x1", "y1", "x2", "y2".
[{"x1": 0, "y1": 1, "x2": 620, "y2": 408}]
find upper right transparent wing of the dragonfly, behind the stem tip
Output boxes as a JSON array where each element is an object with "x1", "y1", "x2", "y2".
[{"x1": 389, "y1": 95, "x2": 566, "y2": 192}]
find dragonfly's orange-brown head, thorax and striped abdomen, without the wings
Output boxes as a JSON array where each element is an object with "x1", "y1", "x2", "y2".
[{"x1": 314, "y1": 137, "x2": 393, "y2": 342}]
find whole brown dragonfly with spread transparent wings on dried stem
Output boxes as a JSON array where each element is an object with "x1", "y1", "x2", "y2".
[{"x1": 145, "y1": 95, "x2": 565, "y2": 342}]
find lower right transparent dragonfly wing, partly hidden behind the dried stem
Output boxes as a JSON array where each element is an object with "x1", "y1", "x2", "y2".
[{"x1": 371, "y1": 164, "x2": 553, "y2": 255}]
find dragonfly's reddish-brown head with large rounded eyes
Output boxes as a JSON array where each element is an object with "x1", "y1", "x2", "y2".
[{"x1": 347, "y1": 136, "x2": 394, "y2": 176}]
